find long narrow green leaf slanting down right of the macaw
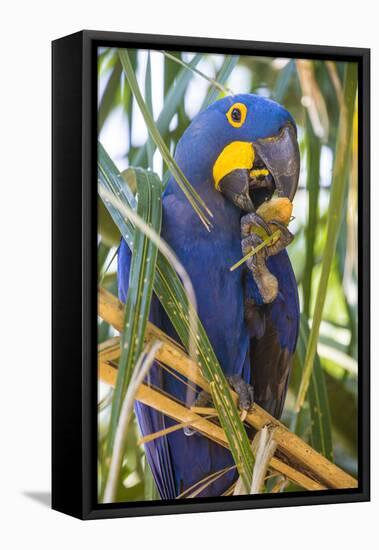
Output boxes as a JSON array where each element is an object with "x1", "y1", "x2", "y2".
[{"x1": 296, "y1": 63, "x2": 357, "y2": 410}]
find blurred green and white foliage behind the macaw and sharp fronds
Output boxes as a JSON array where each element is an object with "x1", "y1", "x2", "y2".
[{"x1": 98, "y1": 48, "x2": 358, "y2": 501}]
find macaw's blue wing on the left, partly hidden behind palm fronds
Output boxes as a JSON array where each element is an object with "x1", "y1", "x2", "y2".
[{"x1": 117, "y1": 240, "x2": 176, "y2": 499}]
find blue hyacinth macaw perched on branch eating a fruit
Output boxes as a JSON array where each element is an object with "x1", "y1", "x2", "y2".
[{"x1": 118, "y1": 94, "x2": 300, "y2": 499}]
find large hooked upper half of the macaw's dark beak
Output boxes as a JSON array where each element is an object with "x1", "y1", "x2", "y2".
[{"x1": 253, "y1": 123, "x2": 300, "y2": 201}]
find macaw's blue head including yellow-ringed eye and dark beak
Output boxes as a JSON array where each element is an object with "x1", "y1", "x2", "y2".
[{"x1": 177, "y1": 94, "x2": 300, "y2": 212}]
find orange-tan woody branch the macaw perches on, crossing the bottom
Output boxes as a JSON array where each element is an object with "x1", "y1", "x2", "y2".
[{"x1": 98, "y1": 288, "x2": 358, "y2": 490}]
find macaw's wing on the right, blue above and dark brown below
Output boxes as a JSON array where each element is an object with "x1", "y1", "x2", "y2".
[{"x1": 248, "y1": 251, "x2": 300, "y2": 418}]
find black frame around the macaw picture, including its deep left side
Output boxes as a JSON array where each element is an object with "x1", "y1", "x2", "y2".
[{"x1": 52, "y1": 30, "x2": 370, "y2": 519}]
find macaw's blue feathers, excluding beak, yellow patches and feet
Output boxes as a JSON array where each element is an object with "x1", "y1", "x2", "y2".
[{"x1": 118, "y1": 94, "x2": 299, "y2": 499}]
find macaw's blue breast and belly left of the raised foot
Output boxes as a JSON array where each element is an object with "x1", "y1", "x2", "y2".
[{"x1": 162, "y1": 193, "x2": 249, "y2": 376}]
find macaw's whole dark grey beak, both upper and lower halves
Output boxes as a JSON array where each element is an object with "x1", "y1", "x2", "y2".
[{"x1": 218, "y1": 123, "x2": 300, "y2": 212}]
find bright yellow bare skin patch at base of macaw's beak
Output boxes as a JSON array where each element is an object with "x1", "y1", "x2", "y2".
[{"x1": 213, "y1": 141, "x2": 255, "y2": 190}]
